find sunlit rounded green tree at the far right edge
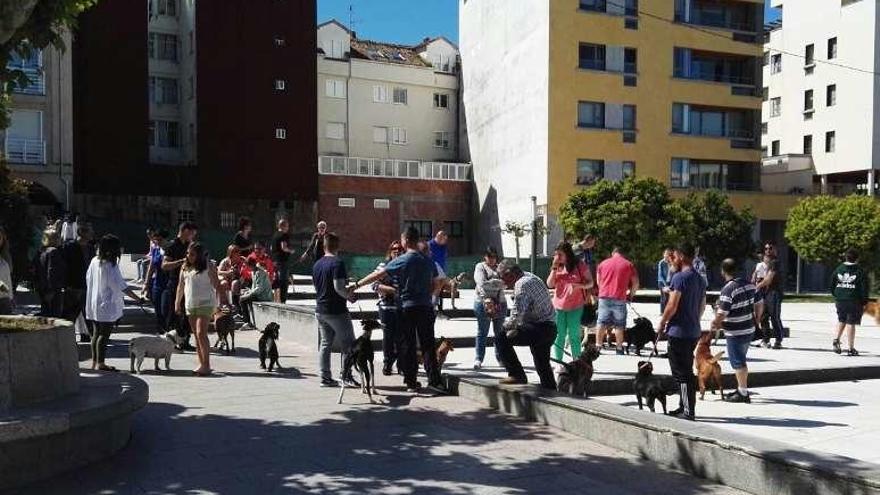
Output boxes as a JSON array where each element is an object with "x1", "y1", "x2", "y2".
[{"x1": 785, "y1": 196, "x2": 880, "y2": 268}]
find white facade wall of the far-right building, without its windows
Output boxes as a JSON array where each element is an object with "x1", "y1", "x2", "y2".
[{"x1": 762, "y1": 0, "x2": 880, "y2": 174}]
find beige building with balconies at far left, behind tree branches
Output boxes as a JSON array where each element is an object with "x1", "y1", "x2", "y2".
[{"x1": 0, "y1": 35, "x2": 73, "y2": 212}]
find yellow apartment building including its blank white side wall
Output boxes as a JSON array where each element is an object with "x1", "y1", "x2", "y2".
[{"x1": 459, "y1": 0, "x2": 794, "y2": 253}]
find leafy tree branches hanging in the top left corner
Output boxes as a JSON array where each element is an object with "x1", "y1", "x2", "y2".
[{"x1": 0, "y1": 0, "x2": 97, "y2": 129}]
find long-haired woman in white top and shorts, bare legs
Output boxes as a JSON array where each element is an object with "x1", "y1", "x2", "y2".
[{"x1": 174, "y1": 242, "x2": 220, "y2": 376}]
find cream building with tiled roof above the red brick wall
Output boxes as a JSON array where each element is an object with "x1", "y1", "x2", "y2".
[{"x1": 317, "y1": 20, "x2": 469, "y2": 180}]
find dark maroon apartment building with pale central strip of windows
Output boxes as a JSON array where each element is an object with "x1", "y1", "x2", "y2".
[{"x1": 72, "y1": 0, "x2": 318, "y2": 237}]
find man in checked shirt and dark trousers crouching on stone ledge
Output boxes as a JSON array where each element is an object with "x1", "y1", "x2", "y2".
[{"x1": 495, "y1": 260, "x2": 556, "y2": 390}]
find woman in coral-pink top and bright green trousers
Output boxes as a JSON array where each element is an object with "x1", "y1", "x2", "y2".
[{"x1": 547, "y1": 241, "x2": 593, "y2": 361}]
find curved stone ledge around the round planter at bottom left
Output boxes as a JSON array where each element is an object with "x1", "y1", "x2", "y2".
[{"x1": 0, "y1": 373, "x2": 149, "y2": 490}]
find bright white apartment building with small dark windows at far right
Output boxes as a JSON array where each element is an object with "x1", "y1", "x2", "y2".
[{"x1": 761, "y1": 0, "x2": 880, "y2": 195}]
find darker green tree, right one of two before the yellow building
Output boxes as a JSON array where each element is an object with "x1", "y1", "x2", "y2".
[{"x1": 665, "y1": 190, "x2": 755, "y2": 266}]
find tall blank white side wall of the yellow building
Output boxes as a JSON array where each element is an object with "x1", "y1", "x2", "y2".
[{"x1": 459, "y1": 0, "x2": 550, "y2": 256}]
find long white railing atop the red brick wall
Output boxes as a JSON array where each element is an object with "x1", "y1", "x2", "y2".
[{"x1": 318, "y1": 156, "x2": 471, "y2": 181}]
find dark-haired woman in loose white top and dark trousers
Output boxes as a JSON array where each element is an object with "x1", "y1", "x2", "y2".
[{"x1": 86, "y1": 235, "x2": 143, "y2": 371}]
